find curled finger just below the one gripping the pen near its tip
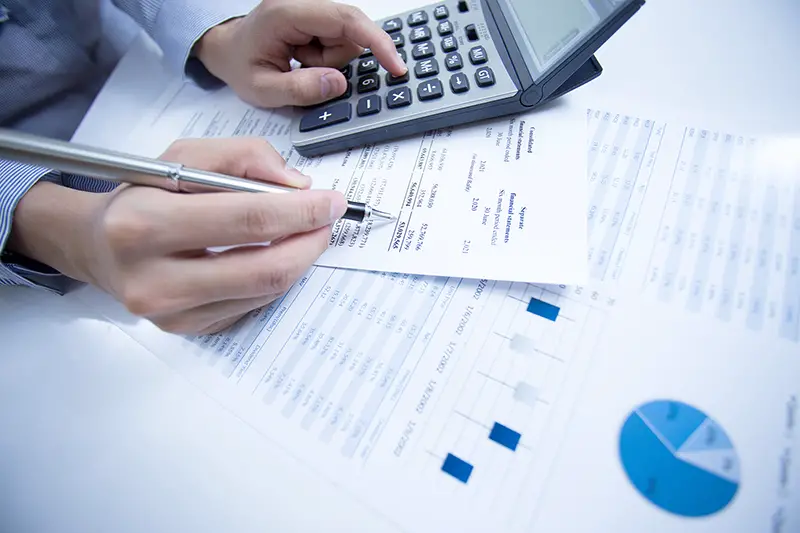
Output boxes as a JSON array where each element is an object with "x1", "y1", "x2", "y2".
[{"x1": 147, "y1": 227, "x2": 331, "y2": 315}]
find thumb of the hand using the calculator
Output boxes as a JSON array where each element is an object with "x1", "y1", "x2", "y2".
[{"x1": 255, "y1": 67, "x2": 347, "y2": 107}]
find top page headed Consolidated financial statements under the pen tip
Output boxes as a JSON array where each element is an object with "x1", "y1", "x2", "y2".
[{"x1": 123, "y1": 84, "x2": 586, "y2": 283}]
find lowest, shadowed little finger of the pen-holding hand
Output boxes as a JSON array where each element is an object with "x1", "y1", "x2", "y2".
[{"x1": 149, "y1": 294, "x2": 280, "y2": 335}]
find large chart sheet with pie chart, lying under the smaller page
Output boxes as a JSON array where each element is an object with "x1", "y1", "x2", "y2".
[{"x1": 79, "y1": 106, "x2": 800, "y2": 533}]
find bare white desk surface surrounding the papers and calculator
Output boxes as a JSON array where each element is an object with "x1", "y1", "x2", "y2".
[{"x1": 0, "y1": 0, "x2": 800, "y2": 533}]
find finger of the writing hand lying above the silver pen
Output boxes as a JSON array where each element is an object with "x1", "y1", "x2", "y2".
[{"x1": 161, "y1": 137, "x2": 311, "y2": 189}]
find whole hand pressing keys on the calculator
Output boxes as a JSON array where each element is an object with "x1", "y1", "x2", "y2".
[{"x1": 195, "y1": 0, "x2": 408, "y2": 108}]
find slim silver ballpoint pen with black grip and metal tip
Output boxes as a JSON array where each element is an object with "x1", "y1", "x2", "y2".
[{"x1": 0, "y1": 128, "x2": 395, "y2": 222}]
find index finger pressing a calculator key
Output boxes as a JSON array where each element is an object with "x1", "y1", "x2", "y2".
[{"x1": 288, "y1": 1, "x2": 407, "y2": 76}]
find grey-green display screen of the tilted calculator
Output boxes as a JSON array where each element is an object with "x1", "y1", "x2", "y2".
[{"x1": 506, "y1": 0, "x2": 625, "y2": 81}]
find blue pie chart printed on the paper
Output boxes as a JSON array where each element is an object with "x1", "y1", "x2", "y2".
[{"x1": 619, "y1": 400, "x2": 740, "y2": 517}]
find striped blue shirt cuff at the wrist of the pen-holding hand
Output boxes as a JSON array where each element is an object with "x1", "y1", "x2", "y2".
[{"x1": 0, "y1": 160, "x2": 65, "y2": 292}]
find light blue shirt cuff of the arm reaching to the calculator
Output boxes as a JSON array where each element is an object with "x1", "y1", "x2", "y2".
[{"x1": 153, "y1": 0, "x2": 258, "y2": 86}]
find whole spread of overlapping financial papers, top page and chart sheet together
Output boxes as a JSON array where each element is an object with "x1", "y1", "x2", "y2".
[{"x1": 79, "y1": 60, "x2": 800, "y2": 533}]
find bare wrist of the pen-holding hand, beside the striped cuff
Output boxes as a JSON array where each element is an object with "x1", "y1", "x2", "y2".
[{"x1": 7, "y1": 182, "x2": 105, "y2": 282}]
